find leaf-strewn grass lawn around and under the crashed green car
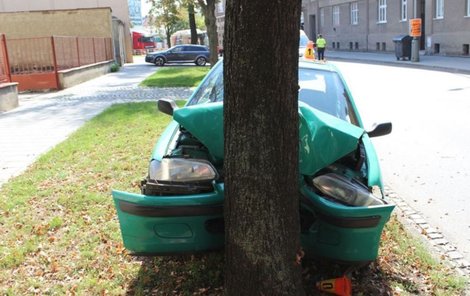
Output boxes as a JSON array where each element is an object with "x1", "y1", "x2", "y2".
[{"x1": 0, "y1": 103, "x2": 464, "y2": 295}]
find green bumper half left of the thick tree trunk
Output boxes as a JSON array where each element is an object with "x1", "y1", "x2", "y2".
[{"x1": 112, "y1": 184, "x2": 224, "y2": 255}]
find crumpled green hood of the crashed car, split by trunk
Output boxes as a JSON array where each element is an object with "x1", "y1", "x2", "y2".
[{"x1": 173, "y1": 102, "x2": 364, "y2": 175}]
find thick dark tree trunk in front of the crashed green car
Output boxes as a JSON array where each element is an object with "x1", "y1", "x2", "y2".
[{"x1": 224, "y1": 0, "x2": 304, "y2": 295}]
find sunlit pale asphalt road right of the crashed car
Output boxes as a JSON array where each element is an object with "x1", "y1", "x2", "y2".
[{"x1": 335, "y1": 62, "x2": 470, "y2": 261}]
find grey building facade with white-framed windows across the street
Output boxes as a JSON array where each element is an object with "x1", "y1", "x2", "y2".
[{"x1": 302, "y1": 0, "x2": 470, "y2": 56}]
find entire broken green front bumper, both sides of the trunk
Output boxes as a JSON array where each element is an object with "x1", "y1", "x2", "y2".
[{"x1": 113, "y1": 180, "x2": 394, "y2": 262}]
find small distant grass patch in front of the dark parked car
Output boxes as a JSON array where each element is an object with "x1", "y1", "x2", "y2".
[{"x1": 140, "y1": 67, "x2": 210, "y2": 87}]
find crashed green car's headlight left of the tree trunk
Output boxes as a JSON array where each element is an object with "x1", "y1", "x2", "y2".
[{"x1": 149, "y1": 158, "x2": 218, "y2": 182}]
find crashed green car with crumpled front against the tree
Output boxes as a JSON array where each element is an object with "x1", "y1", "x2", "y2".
[{"x1": 112, "y1": 61, "x2": 394, "y2": 262}]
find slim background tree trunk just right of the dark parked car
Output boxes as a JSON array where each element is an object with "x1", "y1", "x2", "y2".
[{"x1": 198, "y1": 0, "x2": 219, "y2": 67}]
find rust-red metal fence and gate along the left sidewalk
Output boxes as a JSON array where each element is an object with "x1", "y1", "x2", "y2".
[{"x1": 0, "y1": 35, "x2": 113, "y2": 90}]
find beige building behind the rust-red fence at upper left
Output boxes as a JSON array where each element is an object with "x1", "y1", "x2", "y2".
[{"x1": 0, "y1": 0, "x2": 133, "y2": 64}]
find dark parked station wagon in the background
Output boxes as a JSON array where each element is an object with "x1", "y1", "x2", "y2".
[{"x1": 145, "y1": 44, "x2": 209, "y2": 66}]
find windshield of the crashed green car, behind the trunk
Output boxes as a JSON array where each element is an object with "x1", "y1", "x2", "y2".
[{"x1": 188, "y1": 63, "x2": 358, "y2": 125}]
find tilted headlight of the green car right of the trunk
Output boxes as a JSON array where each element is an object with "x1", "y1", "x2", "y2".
[{"x1": 313, "y1": 173, "x2": 385, "y2": 207}]
